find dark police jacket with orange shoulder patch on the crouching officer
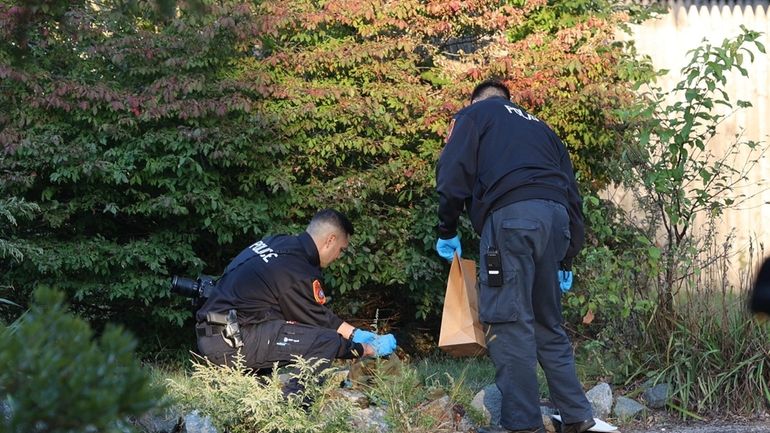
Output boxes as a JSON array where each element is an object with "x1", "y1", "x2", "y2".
[{"x1": 196, "y1": 232, "x2": 342, "y2": 329}]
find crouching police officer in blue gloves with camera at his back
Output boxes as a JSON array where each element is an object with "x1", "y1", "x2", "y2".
[{"x1": 196, "y1": 209, "x2": 396, "y2": 384}]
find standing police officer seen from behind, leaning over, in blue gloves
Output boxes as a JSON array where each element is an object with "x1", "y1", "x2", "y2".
[{"x1": 436, "y1": 81, "x2": 594, "y2": 433}]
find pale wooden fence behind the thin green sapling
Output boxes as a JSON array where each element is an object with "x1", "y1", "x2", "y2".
[{"x1": 611, "y1": 0, "x2": 770, "y2": 286}]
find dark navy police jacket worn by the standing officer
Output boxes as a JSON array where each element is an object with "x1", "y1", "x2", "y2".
[{"x1": 436, "y1": 97, "x2": 585, "y2": 258}]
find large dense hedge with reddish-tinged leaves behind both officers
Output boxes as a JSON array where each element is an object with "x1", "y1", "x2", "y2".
[{"x1": 0, "y1": 0, "x2": 642, "y2": 351}]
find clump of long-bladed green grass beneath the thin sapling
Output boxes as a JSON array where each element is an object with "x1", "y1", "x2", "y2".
[{"x1": 652, "y1": 293, "x2": 770, "y2": 418}]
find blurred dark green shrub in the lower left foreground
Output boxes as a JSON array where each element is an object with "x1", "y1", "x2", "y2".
[{"x1": 0, "y1": 289, "x2": 162, "y2": 433}]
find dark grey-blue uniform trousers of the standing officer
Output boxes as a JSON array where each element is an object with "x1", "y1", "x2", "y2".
[{"x1": 479, "y1": 200, "x2": 592, "y2": 430}]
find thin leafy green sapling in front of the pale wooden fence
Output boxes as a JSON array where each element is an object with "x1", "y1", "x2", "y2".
[{"x1": 621, "y1": 26, "x2": 765, "y2": 318}]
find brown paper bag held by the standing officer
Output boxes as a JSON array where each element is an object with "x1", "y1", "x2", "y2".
[{"x1": 438, "y1": 254, "x2": 487, "y2": 357}]
